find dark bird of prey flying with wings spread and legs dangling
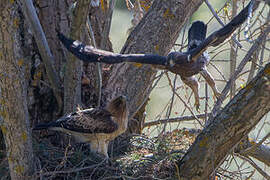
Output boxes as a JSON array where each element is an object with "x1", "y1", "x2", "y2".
[{"x1": 58, "y1": 0, "x2": 255, "y2": 109}]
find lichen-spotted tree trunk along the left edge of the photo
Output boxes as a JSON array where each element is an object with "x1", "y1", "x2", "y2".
[{"x1": 0, "y1": 1, "x2": 34, "y2": 180}]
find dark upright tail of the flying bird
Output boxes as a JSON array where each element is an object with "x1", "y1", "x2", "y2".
[{"x1": 188, "y1": 21, "x2": 207, "y2": 50}]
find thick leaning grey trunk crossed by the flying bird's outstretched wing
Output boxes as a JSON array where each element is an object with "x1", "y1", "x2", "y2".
[{"x1": 105, "y1": 0, "x2": 203, "y2": 133}]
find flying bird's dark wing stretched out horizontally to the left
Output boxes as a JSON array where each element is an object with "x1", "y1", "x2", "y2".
[{"x1": 57, "y1": 32, "x2": 166, "y2": 65}]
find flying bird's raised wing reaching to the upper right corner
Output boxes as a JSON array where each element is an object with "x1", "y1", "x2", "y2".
[{"x1": 188, "y1": 0, "x2": 255, "y2": 61}]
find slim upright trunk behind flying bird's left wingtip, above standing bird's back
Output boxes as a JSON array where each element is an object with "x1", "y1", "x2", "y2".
[{"x1": 64, "y1": 0, "x2": 89, "y2": 113}]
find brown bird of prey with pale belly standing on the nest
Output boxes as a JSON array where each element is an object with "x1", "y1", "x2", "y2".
[{"x1": 33, "y1": 96, "x2": 128, "y2": 157}]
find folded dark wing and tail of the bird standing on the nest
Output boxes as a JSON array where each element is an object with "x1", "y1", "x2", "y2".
[{"x1": 34, "y1": 108, "x2": 118, "y2": 133}]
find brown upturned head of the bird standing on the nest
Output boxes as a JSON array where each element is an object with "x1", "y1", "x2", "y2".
[{"x1": 107, "y1": 96, "x2": 128, "y2": 118}]
